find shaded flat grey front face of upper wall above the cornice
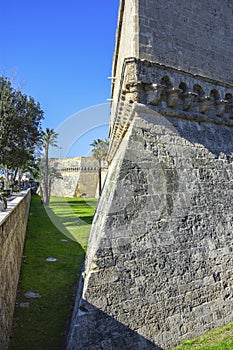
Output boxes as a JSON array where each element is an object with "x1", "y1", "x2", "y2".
[{"x1": 137, "y1": 0, "x2": 233, "y2": 84}]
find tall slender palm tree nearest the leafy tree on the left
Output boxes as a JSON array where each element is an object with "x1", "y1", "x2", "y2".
[{"x1": 42, "y1": 128, "x2": 58, "y2": 205}]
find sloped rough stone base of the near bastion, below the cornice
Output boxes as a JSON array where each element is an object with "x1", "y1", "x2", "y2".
[{"x1": 68, "y1": 104, "x2": 233, "y2": 350}]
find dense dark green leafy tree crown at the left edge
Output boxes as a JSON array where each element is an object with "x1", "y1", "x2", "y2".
[{"x1": 0, "y1": 77, "x2": 43, "y2": 170}]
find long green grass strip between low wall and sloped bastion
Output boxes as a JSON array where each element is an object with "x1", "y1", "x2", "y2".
[{"x1": 9, "y1": 196, "x2": 97, "y2": 350}]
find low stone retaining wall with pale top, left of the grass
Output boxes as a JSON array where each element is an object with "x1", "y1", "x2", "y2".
[{"x1": 0, "y1": 191, "x2": 31, "y2": 350}]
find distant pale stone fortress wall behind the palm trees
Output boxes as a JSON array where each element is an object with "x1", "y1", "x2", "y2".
[{"x1": 50, "y1": 157, "x2": 107, "y2": 198}]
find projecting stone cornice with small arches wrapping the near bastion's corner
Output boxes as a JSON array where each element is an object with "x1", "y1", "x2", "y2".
[{"x1": 109, "y1": 58, "x2": 233, "y2": 160}]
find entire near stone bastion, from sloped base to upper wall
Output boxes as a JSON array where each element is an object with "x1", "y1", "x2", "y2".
[{"x1": 67, "y1": 0, "x2": 233, "y2": 350}]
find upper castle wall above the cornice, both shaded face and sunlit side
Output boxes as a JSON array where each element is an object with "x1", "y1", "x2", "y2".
[{"x1": 110, "y1": 0, "x2": 233, "y2": 144}]
